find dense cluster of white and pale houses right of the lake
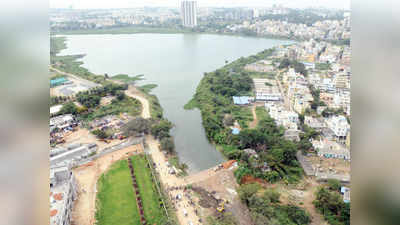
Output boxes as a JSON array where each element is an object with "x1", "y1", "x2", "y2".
[{"x1": 233, "y1": 40, "x2": 351, "y2": 199}]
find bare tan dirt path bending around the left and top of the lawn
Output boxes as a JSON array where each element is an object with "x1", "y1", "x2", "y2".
[{"x1": 72, "y1": 145, "x2": 143, "y2": 225}]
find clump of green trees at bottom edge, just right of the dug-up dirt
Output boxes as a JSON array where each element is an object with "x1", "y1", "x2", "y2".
[{"x1": 238, "y1": 183, "x2": 311, "y2": 225}]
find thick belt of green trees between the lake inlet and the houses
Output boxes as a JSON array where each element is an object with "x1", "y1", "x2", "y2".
[{"x1": 186, "y1": 49, "x2": 302, "y2": 183}]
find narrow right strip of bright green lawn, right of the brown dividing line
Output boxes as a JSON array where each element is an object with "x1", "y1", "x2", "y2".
[{"x1": 131, "y1": 155, "x2": 167, "y2": 224}]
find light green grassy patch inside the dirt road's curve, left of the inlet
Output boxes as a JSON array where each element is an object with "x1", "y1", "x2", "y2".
[{"x1": 82, "y1": 96, "x2": 142, "y2": 121}]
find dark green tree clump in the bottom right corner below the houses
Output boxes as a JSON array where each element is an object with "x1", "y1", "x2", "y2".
[{"x1": 313, "y1": 185, "x2": 350, "y2": 225}]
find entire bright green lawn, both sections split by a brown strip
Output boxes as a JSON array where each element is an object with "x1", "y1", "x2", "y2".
[{"x1": 96, "y1": 155, "x2": 167, "y2": 225}]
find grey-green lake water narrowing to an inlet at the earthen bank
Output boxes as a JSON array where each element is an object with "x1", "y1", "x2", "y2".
[{"x1": 61, "y1": 34, "x2": 292, "y2": 172}]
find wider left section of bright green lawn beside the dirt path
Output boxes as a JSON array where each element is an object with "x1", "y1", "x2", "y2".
[{"x1": 96, "y1": 160, "x2": 140, "y2": 225}]
